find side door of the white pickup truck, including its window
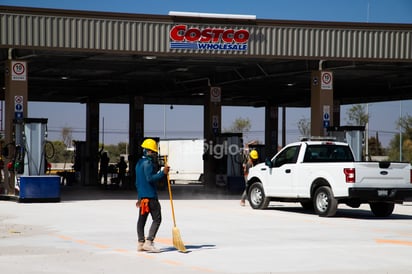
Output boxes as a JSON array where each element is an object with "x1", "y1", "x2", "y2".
[{"x1": 267, "y1": 145, "x2": 300, "y2": 197}]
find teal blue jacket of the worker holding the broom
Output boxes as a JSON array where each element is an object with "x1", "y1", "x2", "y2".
[{"x1": 136, "y1": 156, "x2": 165, "y2": 200}]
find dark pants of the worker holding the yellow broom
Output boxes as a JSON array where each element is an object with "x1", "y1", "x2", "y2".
[{"x1": 137, "y1": 199, "x2": 162, "y2": 242}]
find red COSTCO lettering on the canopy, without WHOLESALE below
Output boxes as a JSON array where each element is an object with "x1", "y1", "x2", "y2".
[{"x1": 169, "y1": 25, "x2": 249, "y2": 44}]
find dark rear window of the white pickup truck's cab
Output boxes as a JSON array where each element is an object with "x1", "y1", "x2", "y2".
[{"x1": 303, "y1": 144, "x2": 355, "y2": 163}]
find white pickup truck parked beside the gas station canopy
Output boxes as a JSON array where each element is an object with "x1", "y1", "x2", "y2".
[{"x1": 246, "y1": 140, "x2": 412, "y2": 217}]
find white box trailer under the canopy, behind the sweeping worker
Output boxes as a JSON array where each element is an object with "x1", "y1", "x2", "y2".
[{"x1": 159, "y1": 139, "x2": 204, "y2": 183}]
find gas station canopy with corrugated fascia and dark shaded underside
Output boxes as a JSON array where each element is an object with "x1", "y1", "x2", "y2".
[{"x1": 0, "y1": 6, "x2": 412, "y2": 107}]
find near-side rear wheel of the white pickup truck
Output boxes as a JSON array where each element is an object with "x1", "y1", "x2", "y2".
[{"x1": 313, "y1": 186, "x2": 338, "y2": 217}]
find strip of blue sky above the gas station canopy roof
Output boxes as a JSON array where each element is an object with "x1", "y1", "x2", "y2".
[{"x1": 0, "y1": 0, "x2": 412, "y2": 23}]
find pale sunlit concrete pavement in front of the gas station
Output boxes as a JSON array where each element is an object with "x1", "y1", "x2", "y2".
[{"x1": 0, "y1": 185, "x2": 412, "y2": 274}]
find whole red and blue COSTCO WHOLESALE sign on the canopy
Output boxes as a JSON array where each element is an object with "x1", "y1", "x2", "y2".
[{"x1": 169, "y1": 25, "x2": 249, "y2": 51}]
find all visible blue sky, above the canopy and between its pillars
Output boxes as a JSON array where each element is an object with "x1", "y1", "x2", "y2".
[{"x1": 0, "y1": 0, "x2": 412, "y2": 148}]
